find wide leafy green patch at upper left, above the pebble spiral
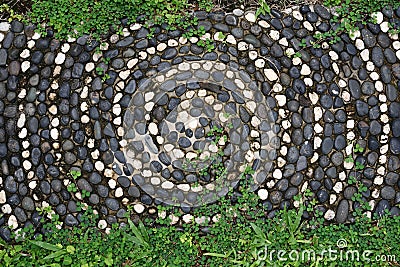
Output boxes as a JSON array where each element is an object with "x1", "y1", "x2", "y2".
[{"x1": 27, "y1": 0, "x2": 212, "y2": 39}]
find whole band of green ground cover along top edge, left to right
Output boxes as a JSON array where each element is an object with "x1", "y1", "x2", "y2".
[{"x1": 0, "y1": 0, "x2": 400, "y2": 44}]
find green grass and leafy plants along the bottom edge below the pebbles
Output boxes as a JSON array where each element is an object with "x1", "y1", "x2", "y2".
[{"x1": 0, "y1": 185, "x2": 400, "y2": 267}]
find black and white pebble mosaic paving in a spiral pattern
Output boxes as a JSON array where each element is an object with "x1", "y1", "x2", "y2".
[{"x1": 0, "y1": 3, "x2": 400, "y2": 240}]
